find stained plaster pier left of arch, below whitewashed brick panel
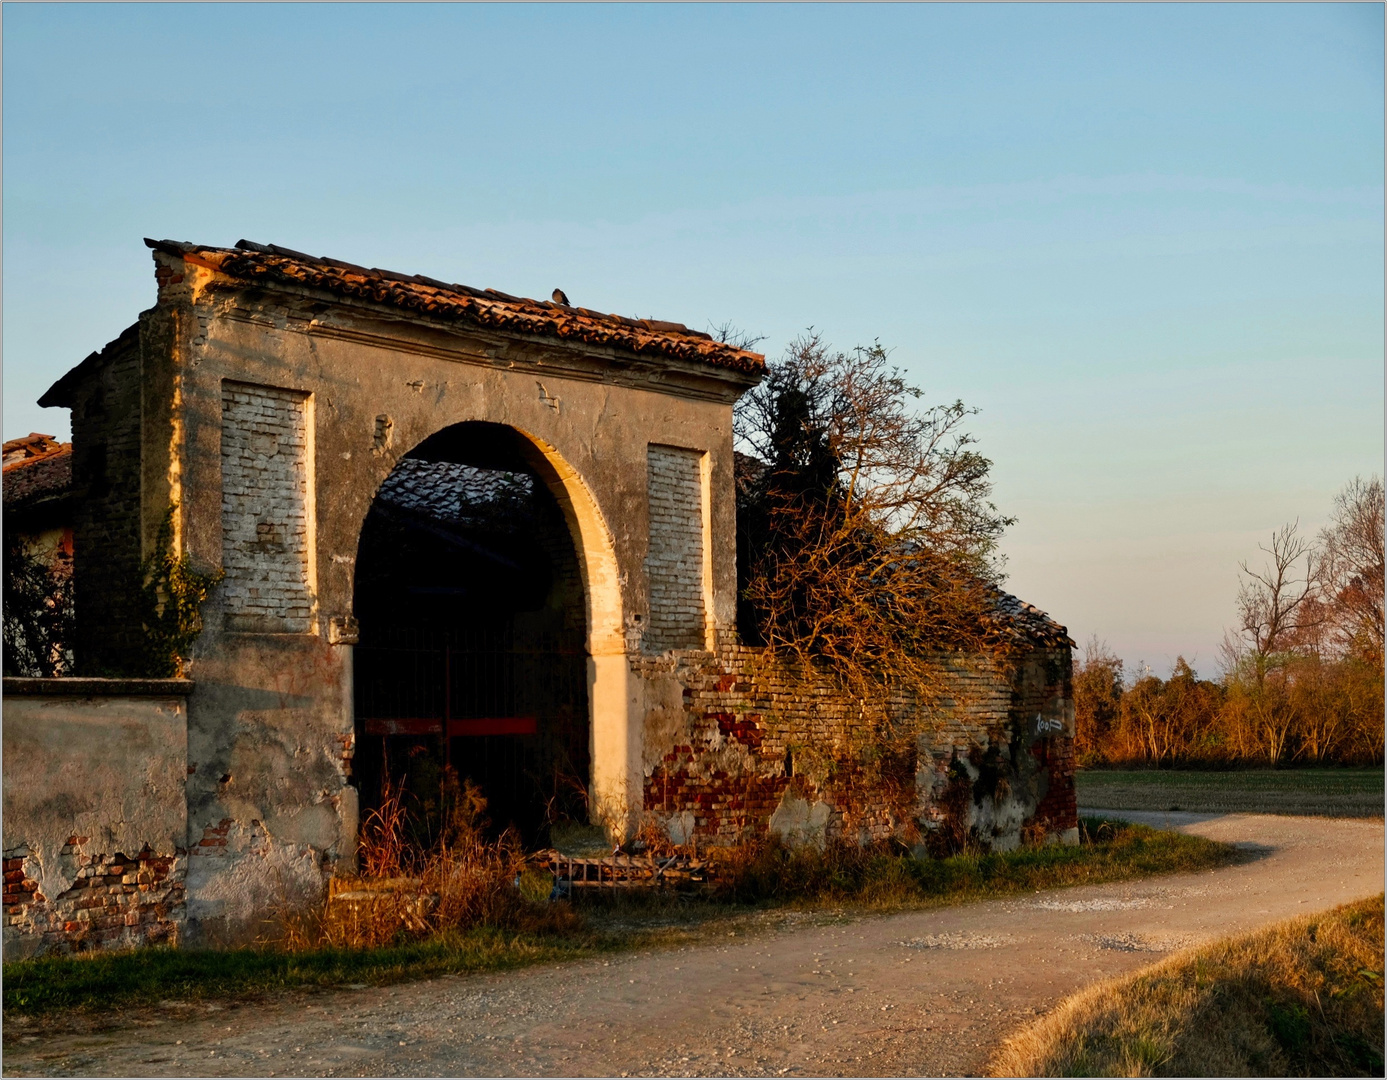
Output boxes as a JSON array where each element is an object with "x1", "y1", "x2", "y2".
[{"x1": 187, "y1": 637, "x2": 356, "y2": 941}]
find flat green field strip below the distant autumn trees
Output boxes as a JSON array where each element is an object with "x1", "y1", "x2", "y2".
[{"x1": 1076, "y1": 768, "x2": 1383, "y2": 818}]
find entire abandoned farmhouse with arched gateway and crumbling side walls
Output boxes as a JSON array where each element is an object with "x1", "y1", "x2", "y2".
[{"x1": 4, "y1": 241, "x2": 1078, "y2": 958}]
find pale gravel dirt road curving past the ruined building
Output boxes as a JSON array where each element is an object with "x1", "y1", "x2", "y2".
[{"x1": 4, "y1": 811, "x2": 1383, "y2": 1076}]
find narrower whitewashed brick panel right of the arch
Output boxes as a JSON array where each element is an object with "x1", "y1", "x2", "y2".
[{"x1": 645, "y1": 445, "x2": 705, "y2": 652}]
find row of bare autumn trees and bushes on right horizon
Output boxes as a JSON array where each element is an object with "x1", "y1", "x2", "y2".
[{"x1": 1074, "y1": 476, "x2": 1384, "y2": 768}]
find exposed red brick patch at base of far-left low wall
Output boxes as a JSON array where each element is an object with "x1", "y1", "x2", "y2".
[{"x1": 4, "y1": 836, "x2": 187, "y2": 952}]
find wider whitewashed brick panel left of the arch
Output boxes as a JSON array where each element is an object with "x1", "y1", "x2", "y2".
[{"x1": 222, "y1": 383, "x2": 312, "y2": 634}]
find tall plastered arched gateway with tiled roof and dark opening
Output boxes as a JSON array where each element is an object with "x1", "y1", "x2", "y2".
[{"x1": 43, "y1": 241, "x2": 761, "y2": 937}]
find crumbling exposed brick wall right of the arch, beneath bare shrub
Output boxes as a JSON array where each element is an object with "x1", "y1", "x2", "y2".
[{"x1": 638, "y1": 643, "x2": 1078, "y2": 847}]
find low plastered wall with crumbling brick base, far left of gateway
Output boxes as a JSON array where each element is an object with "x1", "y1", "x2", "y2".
[{"x1": 3, "y1": 678, "x2": 191, "y2": 959}]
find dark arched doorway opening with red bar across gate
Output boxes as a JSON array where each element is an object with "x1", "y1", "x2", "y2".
[{"x1": 354, "y1": 423, "x2": 589, "y2": 844}]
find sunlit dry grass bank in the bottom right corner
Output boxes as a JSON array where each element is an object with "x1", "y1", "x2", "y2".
[{"x1": 992, "y1": 896, "x2": 1383, "y2": 1076}]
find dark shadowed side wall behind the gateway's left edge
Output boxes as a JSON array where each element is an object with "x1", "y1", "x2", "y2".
[{"x1": 72, "y1": 324, "x2": 141, "y2": 675}]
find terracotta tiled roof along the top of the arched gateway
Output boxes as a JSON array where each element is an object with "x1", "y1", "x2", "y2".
[{"x1": 144, "y1": 238, "x2": 766, "y2": 374}]
